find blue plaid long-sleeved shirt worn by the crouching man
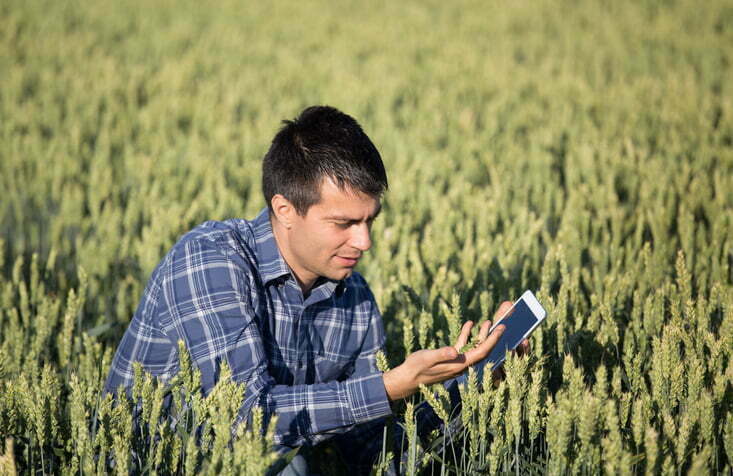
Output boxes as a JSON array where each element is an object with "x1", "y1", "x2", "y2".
[{"x1": 105, "y1": 209, "x2": 391, "y2": 446}]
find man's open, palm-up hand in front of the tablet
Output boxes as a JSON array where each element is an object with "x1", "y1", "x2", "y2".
[{"x1": 383, "y1": 316, "x2": 511, "y2": 401}]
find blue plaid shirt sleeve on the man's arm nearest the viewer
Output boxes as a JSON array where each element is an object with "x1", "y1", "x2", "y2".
[{"x1": 159, "y1": 240, "x2": 391, "y2": 446}]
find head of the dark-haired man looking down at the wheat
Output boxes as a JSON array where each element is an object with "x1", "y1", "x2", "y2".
[{"x1": 262, "y1": 106, "x2": 387, "y2": 290}]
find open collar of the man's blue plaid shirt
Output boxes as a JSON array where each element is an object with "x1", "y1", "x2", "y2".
[{"x1": 252, "y1": 207, "x2": 345, "y2": 300}]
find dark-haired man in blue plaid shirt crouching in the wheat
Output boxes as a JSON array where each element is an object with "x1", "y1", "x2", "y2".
[{"x1": 106, "y1": 107, "x2": 516, "y2": 472}]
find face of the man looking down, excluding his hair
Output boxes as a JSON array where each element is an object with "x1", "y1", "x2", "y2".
[{"x1": 288, "y1": 179, "x2": 381, "y2": 283}]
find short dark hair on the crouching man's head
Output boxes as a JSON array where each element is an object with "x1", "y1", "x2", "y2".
[{"x1": 262, "y1": 106, "x2": 388, "y2": 216}]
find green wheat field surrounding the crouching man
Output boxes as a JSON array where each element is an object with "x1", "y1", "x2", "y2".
[{"x1": 0, "y1": 0, "x2": 733, "y2": 474}]
